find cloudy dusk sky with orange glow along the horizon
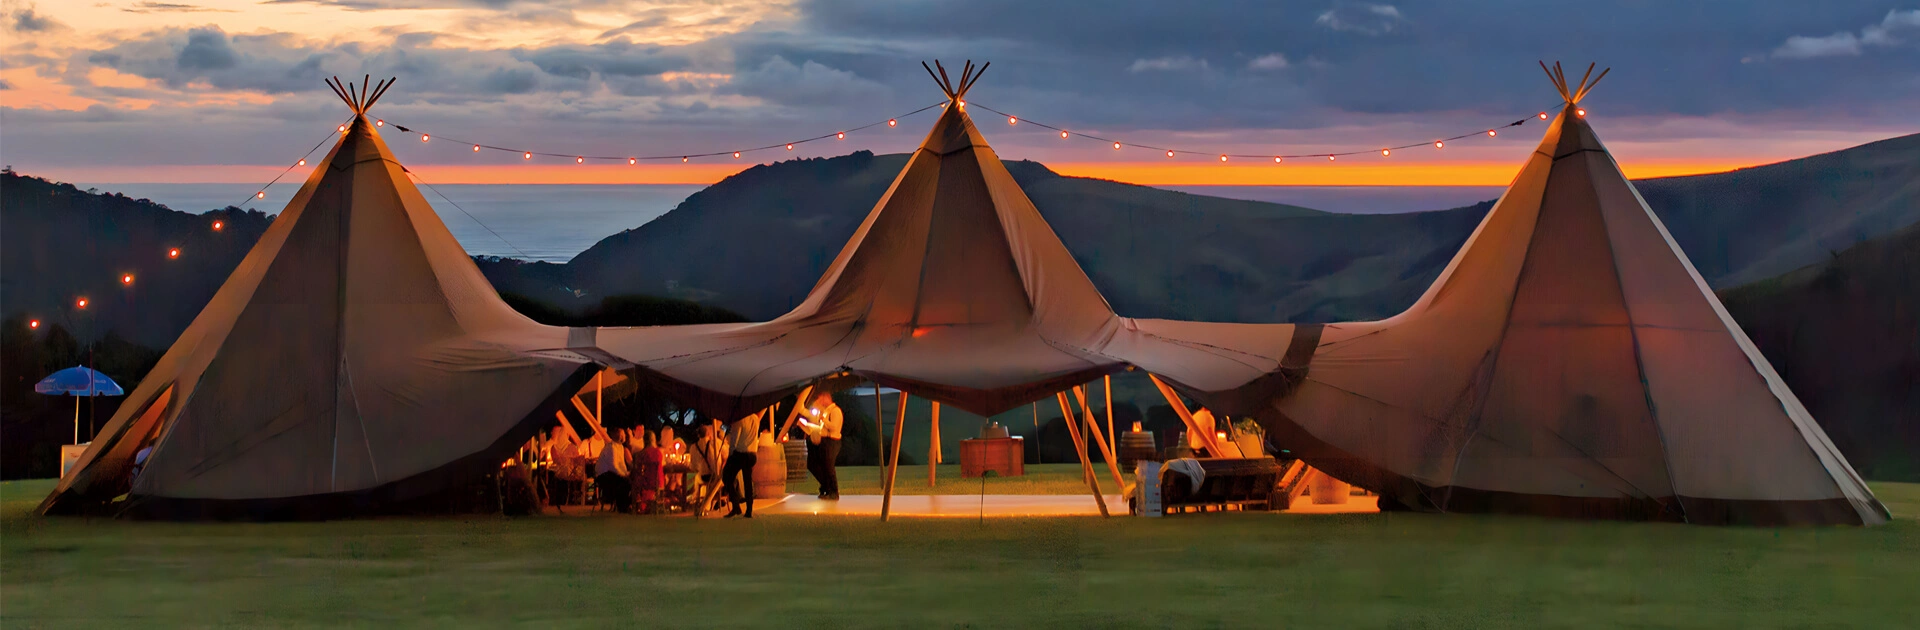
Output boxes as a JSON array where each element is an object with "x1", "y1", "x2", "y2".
[{"x1": 0, "y1": 0, "x2": 1920, "y2": 184}]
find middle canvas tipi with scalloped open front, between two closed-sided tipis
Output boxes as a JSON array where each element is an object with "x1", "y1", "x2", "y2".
[{"x1": 597, "y1": 62, "x2": 1292, "y2": 417}]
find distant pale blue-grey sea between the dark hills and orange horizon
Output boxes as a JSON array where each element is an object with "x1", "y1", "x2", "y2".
[{"x1": 86, "y1": 182, "x2": 1501, "y2": 263}]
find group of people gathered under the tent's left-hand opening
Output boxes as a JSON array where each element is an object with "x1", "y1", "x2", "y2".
[{"x1": 507, "y1": 392, "x2": 845, "y2": 519}]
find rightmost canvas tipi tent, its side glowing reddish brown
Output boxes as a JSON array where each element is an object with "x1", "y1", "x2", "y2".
[{"x1": 1261, "y1": 65, "x2": 1887, "y2": 524}]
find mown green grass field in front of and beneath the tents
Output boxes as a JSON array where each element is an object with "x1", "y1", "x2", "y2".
[{"x1": 0, "y1": 474, "x2": 1920, "y2": 628}]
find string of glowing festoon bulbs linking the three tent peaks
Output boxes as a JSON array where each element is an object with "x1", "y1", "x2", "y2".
[{"x1": 232, "y1": 100, "x2": 1586, "y2": 211}]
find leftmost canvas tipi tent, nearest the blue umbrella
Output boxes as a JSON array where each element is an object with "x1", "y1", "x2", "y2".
[{"x1": 40, "y1": 83, "x2": 597, "y2": 517}]
